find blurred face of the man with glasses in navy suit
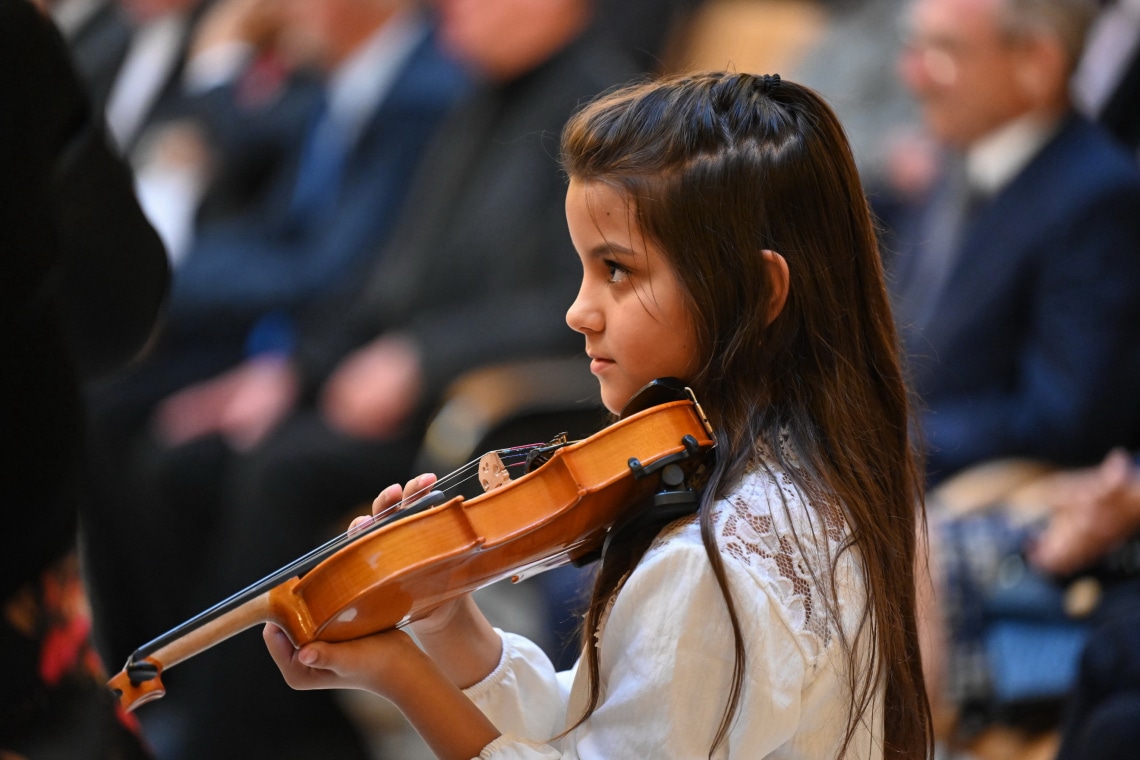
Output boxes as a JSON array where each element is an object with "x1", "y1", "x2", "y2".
[{"x1": 899, "y1": 0, "x2": 1035, "y2": 148}]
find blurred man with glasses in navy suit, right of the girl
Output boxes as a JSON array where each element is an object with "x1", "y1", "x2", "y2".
[{"x1": 886, "y1": 0, "x2": 1140, "y2": 483}]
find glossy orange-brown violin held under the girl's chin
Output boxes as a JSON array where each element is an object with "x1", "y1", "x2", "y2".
[{"x1": 108, "y1": 379, "x2": 714, "y2": 711}]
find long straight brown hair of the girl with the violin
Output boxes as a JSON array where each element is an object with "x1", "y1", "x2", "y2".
[{"x1": 562, "y1": 73, "x2": 933, "y2": 759}]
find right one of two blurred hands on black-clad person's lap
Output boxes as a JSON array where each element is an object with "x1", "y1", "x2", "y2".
[{"x1": 320, "y1": 335, "x2": 423, "y2": 439}]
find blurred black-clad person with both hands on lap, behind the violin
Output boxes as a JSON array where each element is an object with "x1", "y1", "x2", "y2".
[{"x1": 82, "y1": 0, "x2": 638, "y2": 758}]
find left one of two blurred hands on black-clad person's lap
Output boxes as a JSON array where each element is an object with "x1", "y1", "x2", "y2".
[{"x1": 154, "y1": 354, "x2": 299, "y2": 451}]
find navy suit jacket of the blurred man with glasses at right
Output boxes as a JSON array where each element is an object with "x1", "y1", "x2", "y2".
[{"x1": 895, "y1": 116, "x2": 1140, "y2": 481}]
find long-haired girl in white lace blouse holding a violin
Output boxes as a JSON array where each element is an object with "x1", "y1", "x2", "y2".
[{"x1": 264, "y1": 73, "x2": 930, "y2": 760}]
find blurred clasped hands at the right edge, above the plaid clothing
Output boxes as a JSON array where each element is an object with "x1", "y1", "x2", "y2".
[{"x1": 1029, "y1": 449, "x2": 1140, "y2": 575}]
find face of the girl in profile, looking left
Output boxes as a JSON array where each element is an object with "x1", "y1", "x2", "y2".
[{"x1": 567, "y1": 179, "x2": 698, "y2": 414}]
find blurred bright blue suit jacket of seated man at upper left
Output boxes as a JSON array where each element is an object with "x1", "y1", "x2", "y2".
[{"x1": 160, "y1": 29, "x2": 467, "y2": 353}]
